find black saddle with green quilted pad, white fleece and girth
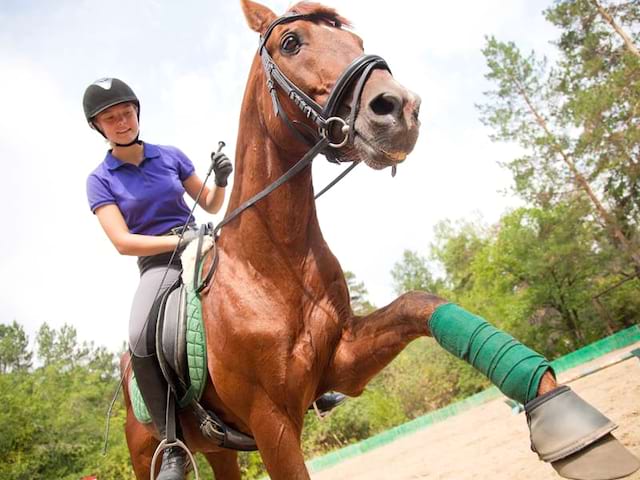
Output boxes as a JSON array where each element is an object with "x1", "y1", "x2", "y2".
[{"x1": 130, "y1": 228, "x2": 257, "y2": 451}]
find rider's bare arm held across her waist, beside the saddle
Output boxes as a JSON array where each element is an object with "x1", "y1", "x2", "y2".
[{"x1": 96, "y1": 203, "x2": 178, "y2": 256}]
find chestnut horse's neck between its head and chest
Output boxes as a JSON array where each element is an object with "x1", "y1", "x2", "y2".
[{"x1": 225, "y1": 86, "x2": 323, "y2": 255}]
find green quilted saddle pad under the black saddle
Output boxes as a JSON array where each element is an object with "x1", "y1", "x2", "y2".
[{"x1": 129, "y1": 285, "x2": 208, "y2": 423}]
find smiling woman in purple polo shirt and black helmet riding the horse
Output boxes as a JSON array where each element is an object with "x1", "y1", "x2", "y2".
[{"x1": 82, "y1": 78, "x2": 345, "y2": 480}]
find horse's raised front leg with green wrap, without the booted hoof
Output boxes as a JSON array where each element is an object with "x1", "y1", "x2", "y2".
[{"x1": 327, "y1": 292, "x2": 556, "y2": 403}]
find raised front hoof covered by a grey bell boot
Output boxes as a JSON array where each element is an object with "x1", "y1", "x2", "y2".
[{"x1": 525, "y1": 386, "x2": 640, "y2": 480}]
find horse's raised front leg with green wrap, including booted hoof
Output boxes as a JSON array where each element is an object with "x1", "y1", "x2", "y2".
[{"x1": 332, "y1": 292, "x2": 640, "y2": 480}]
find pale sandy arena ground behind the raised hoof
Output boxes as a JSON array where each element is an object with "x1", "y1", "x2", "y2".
[{"x1": 312, "y1": 342, "x2": 640, "y2": 480}]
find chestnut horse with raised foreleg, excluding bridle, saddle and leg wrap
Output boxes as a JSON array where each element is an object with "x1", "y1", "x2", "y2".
[{"x1": 125, "y1": 0, "x2": 444, "y2": 480}]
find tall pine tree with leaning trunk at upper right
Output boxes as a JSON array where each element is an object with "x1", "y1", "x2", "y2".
[{"x1": 479, "y1": 0, "x2": 640, "y2": 272}]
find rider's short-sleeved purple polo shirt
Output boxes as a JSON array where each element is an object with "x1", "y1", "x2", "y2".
[{"x1": 87, "y1": 143, "x2": 195, "y2": 235}]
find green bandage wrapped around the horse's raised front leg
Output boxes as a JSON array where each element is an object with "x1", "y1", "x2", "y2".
[{"x1": 429, "y1": 303, "x2": 553, "y2": 404}]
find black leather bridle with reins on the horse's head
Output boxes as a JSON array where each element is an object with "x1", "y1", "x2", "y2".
[{"x1": 213, "y1": 12, "x2": 391, "y2": 237}]
